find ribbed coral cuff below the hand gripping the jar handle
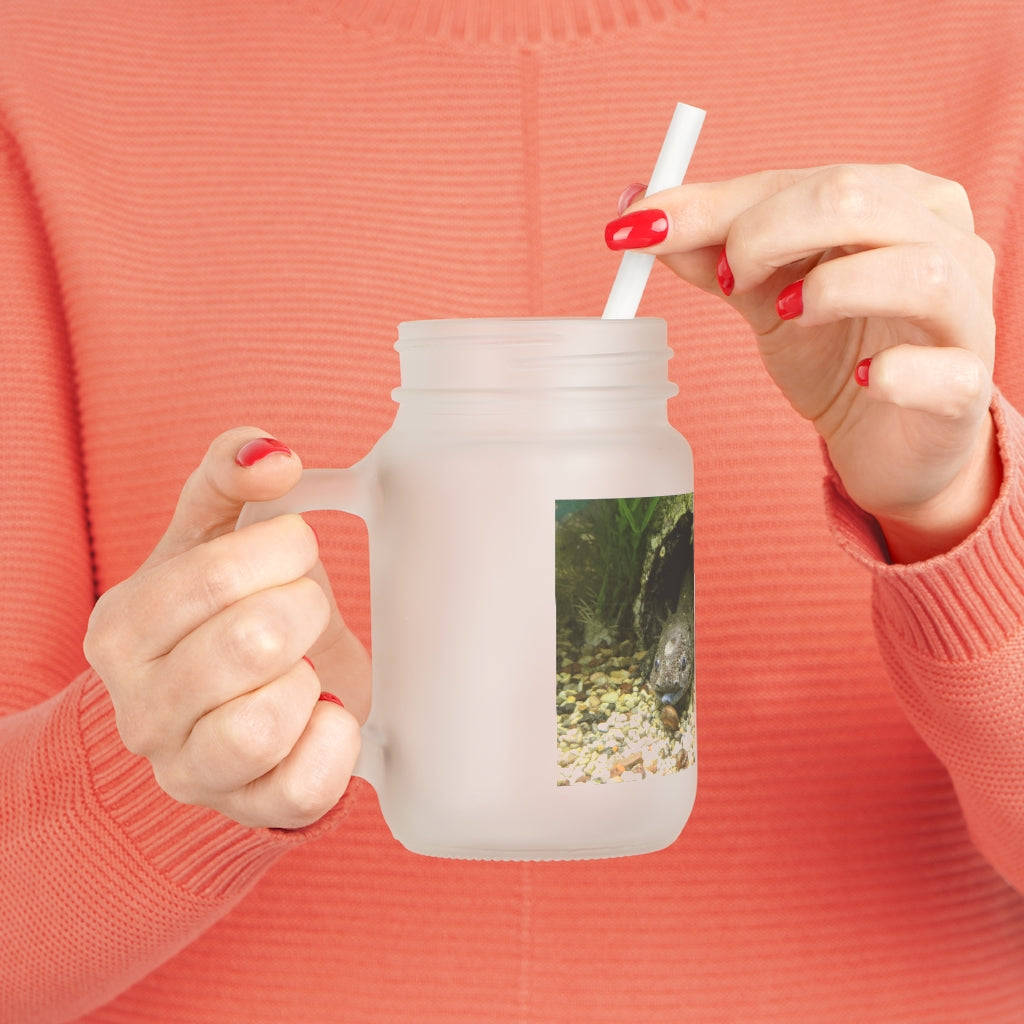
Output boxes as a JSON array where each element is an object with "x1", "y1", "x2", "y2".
[{"x1": 79, "y1": 672, "x2": 350, "y2": 902}]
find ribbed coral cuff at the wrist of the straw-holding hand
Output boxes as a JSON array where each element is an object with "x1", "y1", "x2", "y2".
[{"x1": 825, "y1": 392, "x2": 1024, "y2": 660}]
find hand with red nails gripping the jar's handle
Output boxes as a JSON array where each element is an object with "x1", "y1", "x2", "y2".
[{"x1": 85, "y1": 428, "x2": 370, "y2": 828}]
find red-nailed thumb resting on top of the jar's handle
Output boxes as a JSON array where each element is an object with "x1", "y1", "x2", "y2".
[{"x1": 145, "y1": 427, "x2": 302, "y2": 565}]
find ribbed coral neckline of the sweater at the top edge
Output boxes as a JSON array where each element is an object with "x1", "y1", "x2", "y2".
[{"x1": 322, "y1": 0, "x2": 708, "y2": 46}]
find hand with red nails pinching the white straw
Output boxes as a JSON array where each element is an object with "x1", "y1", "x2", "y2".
[{"x1": 606, "y1": 166, "x2": 1001, "y2": 562}]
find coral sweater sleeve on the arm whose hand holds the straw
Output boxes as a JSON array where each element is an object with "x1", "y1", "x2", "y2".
[{"x1": 825, "y1": 393, "x2": 1024, "y2": 892}]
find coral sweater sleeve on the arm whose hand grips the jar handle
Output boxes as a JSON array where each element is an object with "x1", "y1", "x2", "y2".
[{"x1": 0, "y1": 133, "x2": 345, "y2": 1024}]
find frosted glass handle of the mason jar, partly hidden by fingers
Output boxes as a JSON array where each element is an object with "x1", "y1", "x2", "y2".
[{"x1": 234, "y1": 460, "x2": 385, "y2": 794}]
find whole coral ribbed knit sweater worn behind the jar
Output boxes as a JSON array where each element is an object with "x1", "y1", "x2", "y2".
[{"x1": 0, "y1": 0, "x2": 1024, "y2": 1024}]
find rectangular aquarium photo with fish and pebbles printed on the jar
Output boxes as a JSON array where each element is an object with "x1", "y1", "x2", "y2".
[{"x1": 555, "y1": 494, "x2": 695, "y2": 785}]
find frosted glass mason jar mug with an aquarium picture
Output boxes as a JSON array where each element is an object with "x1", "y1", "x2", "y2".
[{"x1": 240, "y1": 318, "x2": 696, "y2": 860}]
